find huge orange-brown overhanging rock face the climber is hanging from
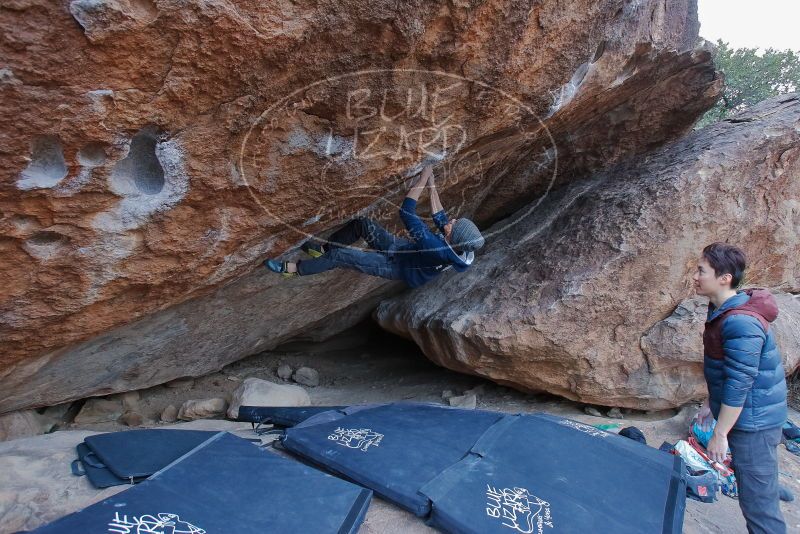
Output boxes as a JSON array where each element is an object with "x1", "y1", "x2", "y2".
[{"x1": 0, "y1": 0, "x2": 720, "y2": 412}]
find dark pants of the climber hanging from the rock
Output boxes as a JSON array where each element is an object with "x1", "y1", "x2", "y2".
[{"x1": 297, "y1": 217, "x2": 410, "y2": 280}]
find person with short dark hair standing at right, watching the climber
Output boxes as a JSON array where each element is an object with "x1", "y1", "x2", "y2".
[{"x1": 693, "y1": 243, "x2": 788, "y2": 534}]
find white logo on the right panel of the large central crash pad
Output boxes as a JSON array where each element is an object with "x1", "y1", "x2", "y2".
[{"x1": 486, "y1": 484, "x2": 553, "y2": 534}]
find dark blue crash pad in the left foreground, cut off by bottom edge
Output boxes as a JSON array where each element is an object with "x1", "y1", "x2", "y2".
[{"x1": 33, "y1": 432, "x2": 372, "y2": 534}]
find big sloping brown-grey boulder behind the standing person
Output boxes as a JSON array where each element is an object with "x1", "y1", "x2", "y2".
[{"x1": 375, "y1": 94, "x2": 800, "y2": 409}]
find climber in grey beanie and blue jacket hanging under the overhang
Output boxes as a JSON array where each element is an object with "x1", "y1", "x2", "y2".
[{"x1": 264, "y1": 165, "x2": 484, "y2": 287}]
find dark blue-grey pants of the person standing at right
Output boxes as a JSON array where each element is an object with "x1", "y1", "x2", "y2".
[{"x1": 728, "y1": 427, "x2": 786, "y2": 534}]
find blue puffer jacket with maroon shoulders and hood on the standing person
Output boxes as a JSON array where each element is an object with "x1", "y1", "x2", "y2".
[{"x1": 703, "y1": 289, "x2": 788, "y2": 431}]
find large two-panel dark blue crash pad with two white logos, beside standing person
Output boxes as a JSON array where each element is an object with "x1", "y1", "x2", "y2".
[{"x1": 282, "y1": 403, "x2": 686, "y2": 534}]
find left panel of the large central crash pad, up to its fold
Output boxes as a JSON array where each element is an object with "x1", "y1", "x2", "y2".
[{"x1": 282, "y1": 403, "x2": 503, "y2": 517}]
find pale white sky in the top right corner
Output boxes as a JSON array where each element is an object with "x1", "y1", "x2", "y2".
[{"x1": 698, "y1": 0, "x2": 800, "y2": 51}]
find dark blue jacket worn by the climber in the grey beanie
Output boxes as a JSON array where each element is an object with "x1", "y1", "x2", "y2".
[{"x1": 395, "y1": 197, "x2": 475, "y2": 287}]
